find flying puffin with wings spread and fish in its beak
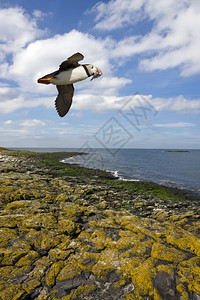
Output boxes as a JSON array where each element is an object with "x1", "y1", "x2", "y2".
[{"x1": 38, "y1": 52, "x2": 103, "y2": 117}]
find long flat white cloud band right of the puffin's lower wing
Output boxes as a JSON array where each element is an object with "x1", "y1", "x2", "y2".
[{"x1": 72, "y1": 94, "x2": 200, "y2": 114}]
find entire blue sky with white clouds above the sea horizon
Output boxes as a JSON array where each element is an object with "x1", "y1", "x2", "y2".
[{"x1": 0, "y1": 0, "x2": 200, "y2": 149}]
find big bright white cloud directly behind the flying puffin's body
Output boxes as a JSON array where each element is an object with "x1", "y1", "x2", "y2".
[{"x1": 1, "y1": 30, "x2": 115, "y2": 94}]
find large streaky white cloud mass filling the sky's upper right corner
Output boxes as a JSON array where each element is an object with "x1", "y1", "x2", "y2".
[{"x1": 92, "y1": 0, "x2": 200, "y2": 76}]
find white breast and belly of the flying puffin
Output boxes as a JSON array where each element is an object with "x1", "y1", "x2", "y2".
[{"x1": 50, "y1": 66, "x2": 88, "y2": 85}]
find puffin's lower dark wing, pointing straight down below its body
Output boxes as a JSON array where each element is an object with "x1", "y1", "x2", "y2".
[{"x1": 55, "y1": 84, "x2": 74, "y2": 117}]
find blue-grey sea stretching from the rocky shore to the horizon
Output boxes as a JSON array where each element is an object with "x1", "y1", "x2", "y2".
[{"x1": 12, "y1": 148, "x2": 200, "y2": 195}]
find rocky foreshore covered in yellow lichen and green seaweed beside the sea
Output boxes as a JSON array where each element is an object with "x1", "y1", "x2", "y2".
[{"x1": 0, "y1": 148, "x2": 200, "y2": 300}]
